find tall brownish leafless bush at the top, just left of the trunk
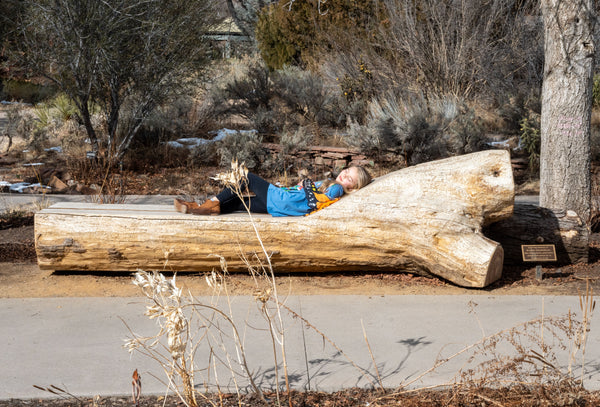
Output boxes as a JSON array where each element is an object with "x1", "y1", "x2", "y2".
[{"x1": 383, "y1": 0, "x2": 543, "y2": 97}]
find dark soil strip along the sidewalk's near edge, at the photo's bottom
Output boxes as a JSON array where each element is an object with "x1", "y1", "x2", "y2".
[{"x1": 0, "y1": 386, "x2": 600, "y2": 407}]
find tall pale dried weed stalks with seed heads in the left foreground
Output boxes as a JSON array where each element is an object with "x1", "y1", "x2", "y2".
[{"x1": 125, "y1": 161, "x2": 372, "y2": 406}]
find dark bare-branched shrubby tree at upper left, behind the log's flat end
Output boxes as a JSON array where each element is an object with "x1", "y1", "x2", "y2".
[{"x1": 14, "y1": 0, "x2": 216, "y2": 166}]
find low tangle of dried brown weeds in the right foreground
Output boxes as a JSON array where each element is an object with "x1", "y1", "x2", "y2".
[{"x1": 377, "y1": 294, "x2": 595, "y2": 405}]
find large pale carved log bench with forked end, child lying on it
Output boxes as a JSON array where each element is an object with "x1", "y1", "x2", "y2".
[{"x1": 35, "y1": 150, "x2": 514, "y2": 287}]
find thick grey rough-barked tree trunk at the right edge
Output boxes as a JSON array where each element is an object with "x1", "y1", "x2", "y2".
[{"x1": 540, "y1": 0, "x2": 595, "y2": 222}]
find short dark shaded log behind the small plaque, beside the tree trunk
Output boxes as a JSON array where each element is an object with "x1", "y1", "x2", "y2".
[{"x1": 484, "y1": 203, "x2": 589, "y2": 265}]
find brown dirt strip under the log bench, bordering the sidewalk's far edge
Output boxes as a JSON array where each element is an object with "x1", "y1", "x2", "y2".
[{"x1": 0, "y1": 216, "x2": 600, "y2": 298}]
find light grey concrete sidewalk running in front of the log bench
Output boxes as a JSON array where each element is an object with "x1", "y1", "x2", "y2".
[{"x1": 0, "y1": 295, "x2": 600, "y2": 399}]
